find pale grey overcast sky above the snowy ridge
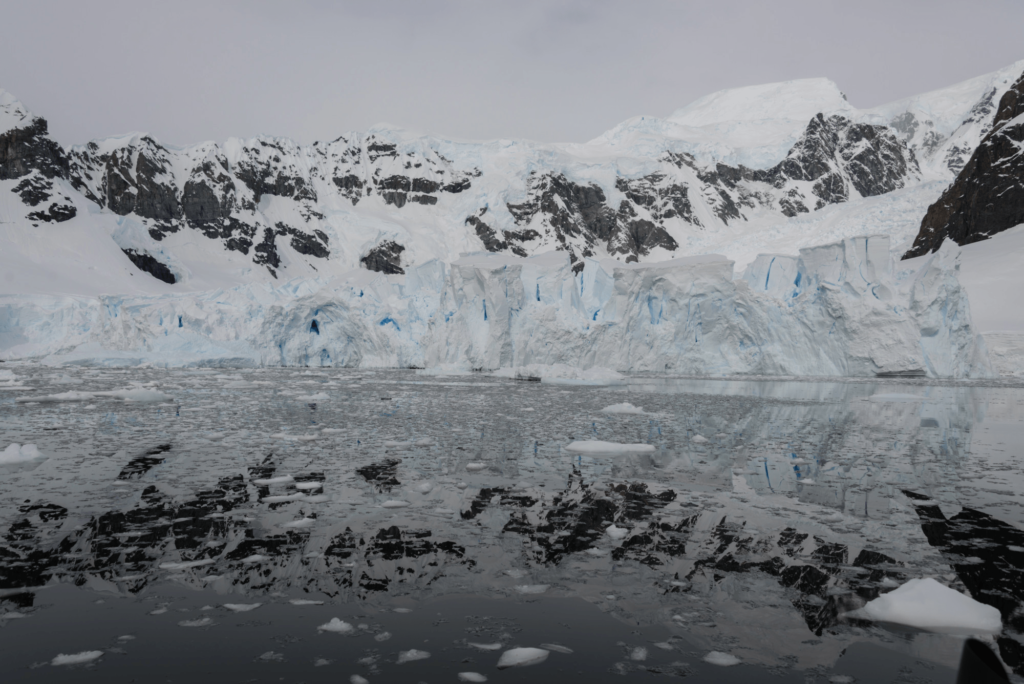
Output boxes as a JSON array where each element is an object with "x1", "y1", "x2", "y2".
[{"x1": 0, "y1": 0, "x2": 1024, "y2": 144}]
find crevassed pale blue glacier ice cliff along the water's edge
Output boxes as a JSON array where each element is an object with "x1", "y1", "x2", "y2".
[{"x1": 0, "y1": 236, "x2": 991, "y2": 378}]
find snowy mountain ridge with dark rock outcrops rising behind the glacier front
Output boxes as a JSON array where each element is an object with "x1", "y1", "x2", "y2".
[{"x1": 0, "y1": 62, "x2": 1024, "y2": 290}]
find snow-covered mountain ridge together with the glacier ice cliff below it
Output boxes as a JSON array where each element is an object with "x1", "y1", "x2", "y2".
[{"x1": 0, "y1": 61, "x2": 1024, "y2": 377}]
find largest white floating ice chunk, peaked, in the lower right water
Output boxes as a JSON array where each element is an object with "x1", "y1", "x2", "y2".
[{"x1": 851, "y1": 578, "x2": 1002, "y2": 634}]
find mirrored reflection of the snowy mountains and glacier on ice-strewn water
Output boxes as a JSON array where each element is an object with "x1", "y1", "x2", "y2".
[{"x1": 0, "y1": 367, "x2": 1024, "y2": 677}]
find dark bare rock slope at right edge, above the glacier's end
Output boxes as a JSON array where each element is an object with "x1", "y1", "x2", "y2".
[{"x1": 903, "y1": 70, "x2": 1024, "y2": 259}]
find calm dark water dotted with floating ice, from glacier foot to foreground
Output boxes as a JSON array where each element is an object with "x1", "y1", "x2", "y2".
[{"x1": 0, "y1": 364, "x2": 1024, "y2": 684}]
